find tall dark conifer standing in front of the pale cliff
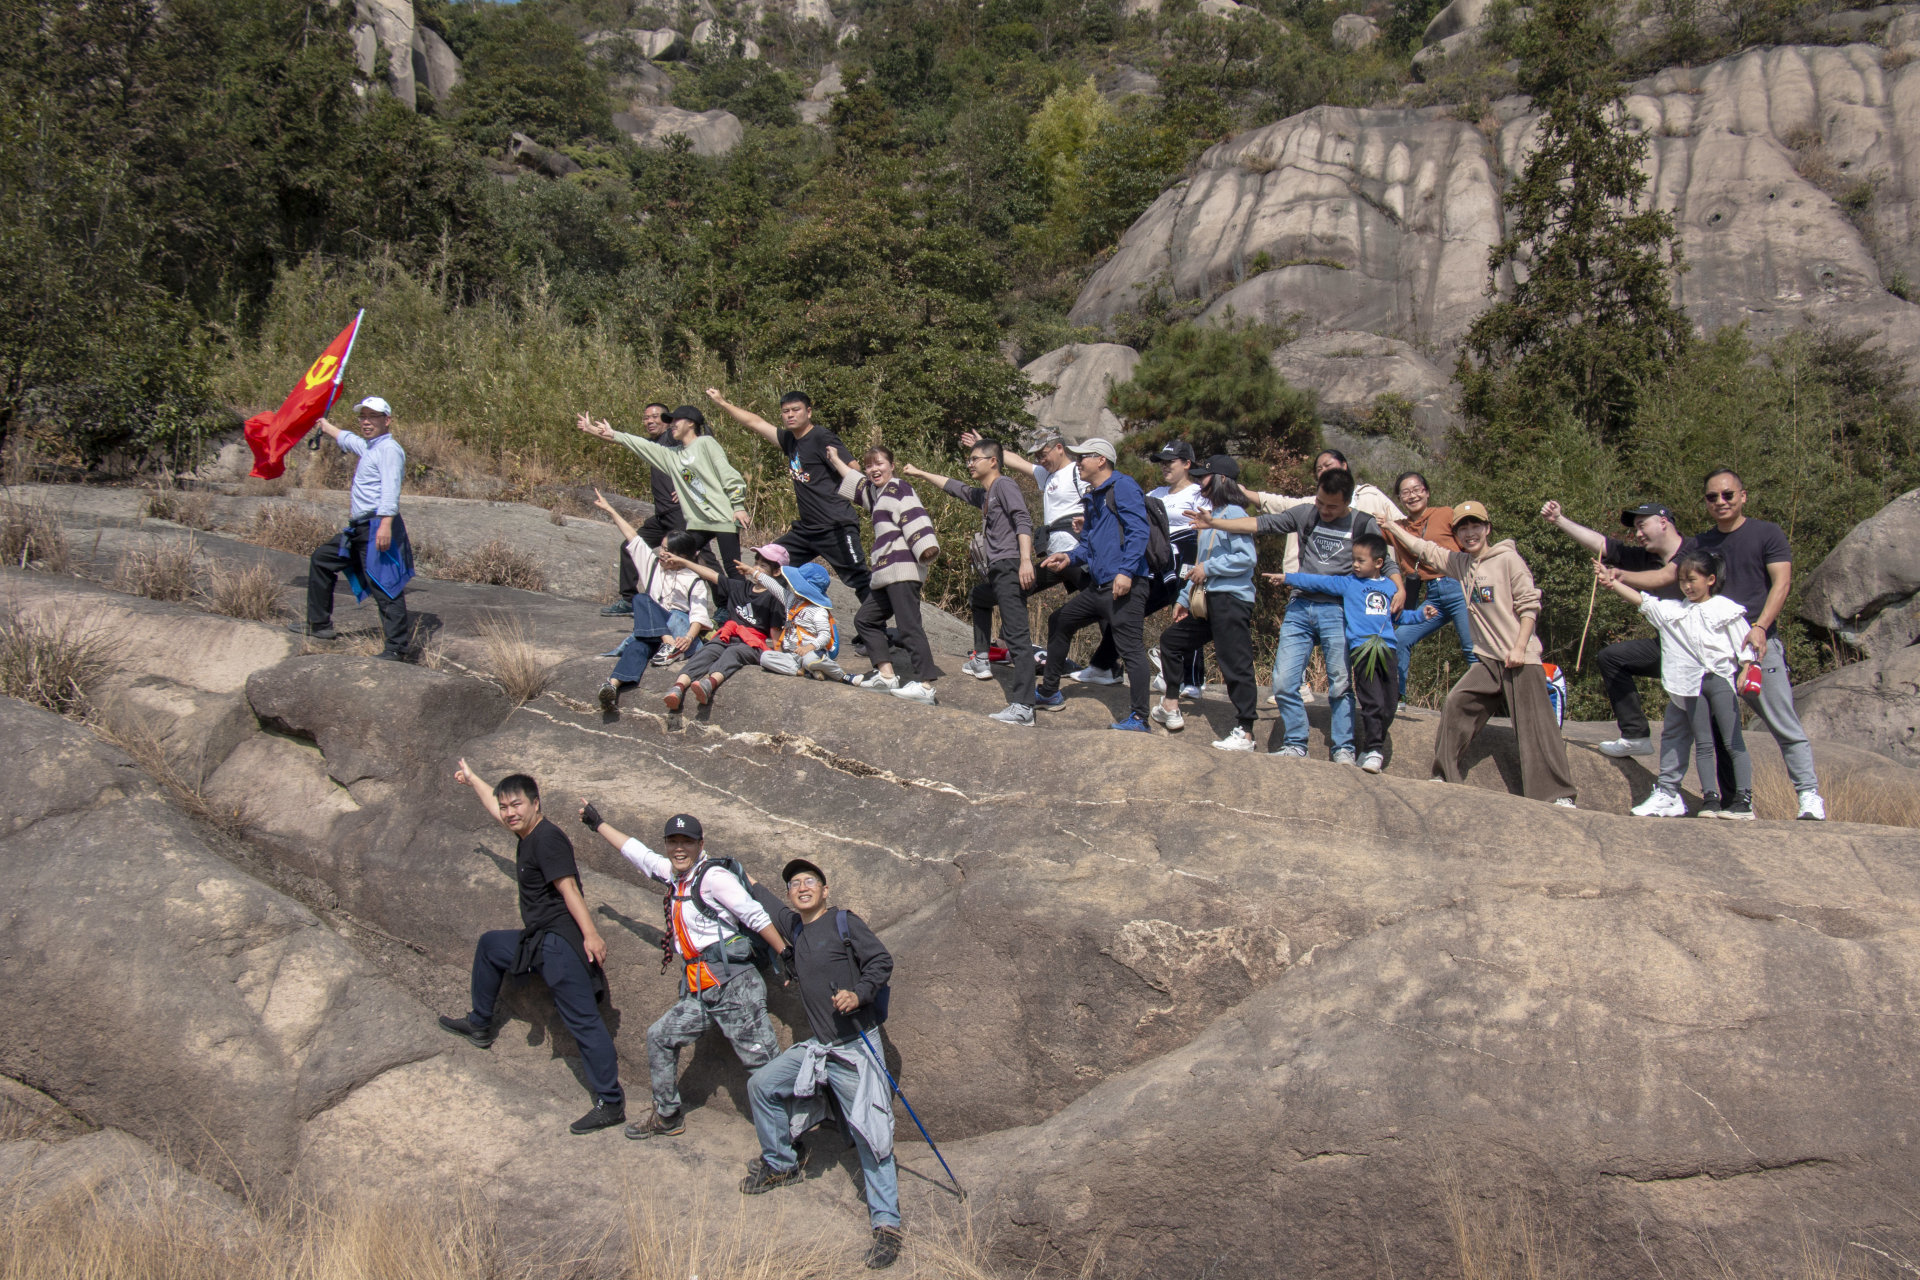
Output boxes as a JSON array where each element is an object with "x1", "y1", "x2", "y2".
[{"x1": 1455, "y1": 0, "x2": 1692, "y2": 461}]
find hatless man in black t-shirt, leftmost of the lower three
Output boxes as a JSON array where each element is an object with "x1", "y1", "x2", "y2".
[{"x1": 440, "y1": 760, "x2": 626, "y2": 1134}]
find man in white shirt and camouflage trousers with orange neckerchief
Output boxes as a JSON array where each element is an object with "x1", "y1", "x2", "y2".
[{"x1": 580, "y1": 804, "x2": 787, "y2": 1138}]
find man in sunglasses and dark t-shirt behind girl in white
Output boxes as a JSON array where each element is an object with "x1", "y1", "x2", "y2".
[{"x1": 1699, "y1": 466, "x2": 1826, "y2": 821}]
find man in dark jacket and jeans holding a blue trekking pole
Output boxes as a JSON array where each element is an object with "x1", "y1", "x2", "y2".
[{"x1": 739, "y1": 858, "x2": 900, "y2": 1268}]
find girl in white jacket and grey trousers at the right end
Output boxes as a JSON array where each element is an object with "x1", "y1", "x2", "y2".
[{"x1": 1594, "y1": 549, "x2": 1753, "y2": 819}]
